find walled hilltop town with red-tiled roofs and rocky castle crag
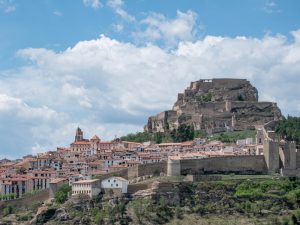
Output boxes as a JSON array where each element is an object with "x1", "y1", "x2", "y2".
[{"x1": 0, "y1": 79, "x2": 300, "y2": 224}]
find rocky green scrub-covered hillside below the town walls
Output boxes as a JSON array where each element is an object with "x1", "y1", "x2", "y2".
[{"x1": 1, "y1": 174, "x2": 300, "y2": 225}]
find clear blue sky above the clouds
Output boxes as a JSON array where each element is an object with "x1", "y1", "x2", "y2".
[{"x1": 0, "y1": 0, "x2": 300, "y2": 68}]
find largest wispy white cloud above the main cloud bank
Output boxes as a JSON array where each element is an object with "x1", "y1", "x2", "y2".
[{"x1": 133, "y1": 10, "x2": 198, "y2": 46}]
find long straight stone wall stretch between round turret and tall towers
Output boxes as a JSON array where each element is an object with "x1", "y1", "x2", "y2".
[{"x1": 174, "y1": 155, "x2": 267, "y2": 175}]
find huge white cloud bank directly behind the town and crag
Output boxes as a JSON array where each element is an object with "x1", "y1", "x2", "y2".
[{"x1": 0, "y1": 26, "x2": 300, "y2": 158}]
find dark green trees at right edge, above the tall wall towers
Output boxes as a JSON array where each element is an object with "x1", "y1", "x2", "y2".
[{"x1": 275, "y1": 116, "x2": 300, "y2": 143}]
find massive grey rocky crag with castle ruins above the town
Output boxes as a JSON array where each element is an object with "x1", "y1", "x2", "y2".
[{"x1": 145, "y1": 79, "x2": 282, "y2": 134}]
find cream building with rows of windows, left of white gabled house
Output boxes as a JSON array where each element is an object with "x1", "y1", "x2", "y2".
[{"x1": 72, "y1": 179, "x2": 101, "y2": 198}]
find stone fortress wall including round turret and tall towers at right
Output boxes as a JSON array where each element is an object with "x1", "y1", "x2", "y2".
[{"x1": 167, "y1": 123, "x2": 300, "y2": 177}]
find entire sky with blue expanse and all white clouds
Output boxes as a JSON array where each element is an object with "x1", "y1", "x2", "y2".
[{"x1": 0, "y1": 0, "x2": 300, "y2": 159}]
